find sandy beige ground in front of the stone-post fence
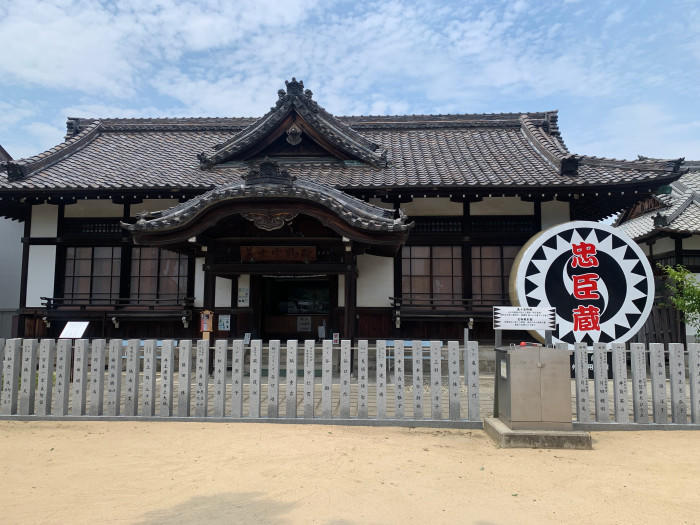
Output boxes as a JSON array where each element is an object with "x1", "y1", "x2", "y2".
[{"x1": 0, "y1": 421, "x2": 700, "y2": 524}]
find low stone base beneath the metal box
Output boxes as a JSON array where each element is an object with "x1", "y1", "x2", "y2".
[{"x1": 484, "y1": 417, "x2": 593, "y2": 450}]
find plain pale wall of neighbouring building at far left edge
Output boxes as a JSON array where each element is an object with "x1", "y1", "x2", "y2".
[{"x1": 0, "y1": 219, "x2": 24, "y2": 310}]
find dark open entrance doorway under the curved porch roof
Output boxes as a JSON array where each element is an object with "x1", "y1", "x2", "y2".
[{"x1": 262, "y1": 275, "x2": 333, "y2": 340}]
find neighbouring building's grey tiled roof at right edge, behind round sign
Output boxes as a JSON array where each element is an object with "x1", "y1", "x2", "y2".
[{"x1": 618, "y1": 162, "x2": 700, "y2": 239}]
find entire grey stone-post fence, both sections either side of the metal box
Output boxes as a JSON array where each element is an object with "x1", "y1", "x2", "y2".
[{"x1": 5, "y1": 339, "x2": 700, "y2": 430}]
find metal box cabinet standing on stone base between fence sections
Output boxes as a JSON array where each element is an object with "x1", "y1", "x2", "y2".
[{"x1": 494, "y1": 346, "x2": 572, "y2": 430}]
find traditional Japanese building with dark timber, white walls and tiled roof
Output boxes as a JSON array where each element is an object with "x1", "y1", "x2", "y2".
[{"x1": 0, "y1": 79, "x2": 686, "y2": 339}]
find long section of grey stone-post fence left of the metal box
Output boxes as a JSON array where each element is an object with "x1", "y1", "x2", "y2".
[{"x1": 0, "y1": 339, "x2": 482, "y2": 428}]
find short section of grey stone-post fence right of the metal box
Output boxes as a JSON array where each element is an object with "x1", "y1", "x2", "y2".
[{"x1": 574, "y1": 343, "x2": 700, "y2": 429}]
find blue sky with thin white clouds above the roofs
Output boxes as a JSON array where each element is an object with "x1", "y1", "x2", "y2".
[{"x1": 0, "y1": 0, "x2": 700, "y2": 159}]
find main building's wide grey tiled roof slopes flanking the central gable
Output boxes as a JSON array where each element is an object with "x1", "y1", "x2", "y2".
[{"x1": 0, "y1": 78, "x2": 683, "y2": 192}]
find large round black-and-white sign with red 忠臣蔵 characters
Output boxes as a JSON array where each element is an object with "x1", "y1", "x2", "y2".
[{"x1": 510, "y1": 221, "x2": 654, "y2": 344}]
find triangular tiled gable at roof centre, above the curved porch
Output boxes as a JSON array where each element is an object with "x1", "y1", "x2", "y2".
[{"x1": 197, "y1": 78, "x2": 387, "y2": 169}]
